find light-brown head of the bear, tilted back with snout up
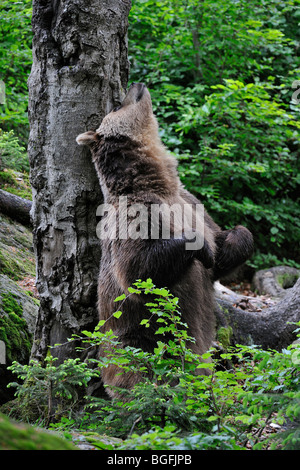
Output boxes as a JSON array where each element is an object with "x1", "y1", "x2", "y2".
[{"x1": 76, "y1": 83, "x2": 160, "y2": 146}]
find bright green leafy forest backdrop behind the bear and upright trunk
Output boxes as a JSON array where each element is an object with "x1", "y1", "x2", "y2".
[{"x1": 0, "y1": 0, "x2": 300, "y2": 269}]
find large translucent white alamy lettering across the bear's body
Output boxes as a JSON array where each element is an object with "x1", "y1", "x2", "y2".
[{"x1": 96, "y1": 196, "x2": 204, "y2": 250}]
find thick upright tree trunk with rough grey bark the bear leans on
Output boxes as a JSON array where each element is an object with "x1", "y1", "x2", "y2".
[{"x1": 28, "y1": 0, "x2": 131, "y2": 360}]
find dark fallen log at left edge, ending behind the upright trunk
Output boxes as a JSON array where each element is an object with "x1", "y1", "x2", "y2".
[{"x1": 0, "y1": 189, "x2": 32, "y2": 225}]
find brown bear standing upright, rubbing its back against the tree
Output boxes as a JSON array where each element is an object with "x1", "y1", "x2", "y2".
[{"x1": 76, "y1": 83, "x2": 253, "y2": 395}]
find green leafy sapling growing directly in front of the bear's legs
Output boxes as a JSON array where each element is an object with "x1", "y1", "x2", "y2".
[{"x1": 75, "y1": 280, "x2": 213, "y2": 437}]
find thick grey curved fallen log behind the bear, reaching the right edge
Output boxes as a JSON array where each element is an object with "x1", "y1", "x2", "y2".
[{"x1": 216, "y1": 278, "x2": 300, "y2": 350}]
